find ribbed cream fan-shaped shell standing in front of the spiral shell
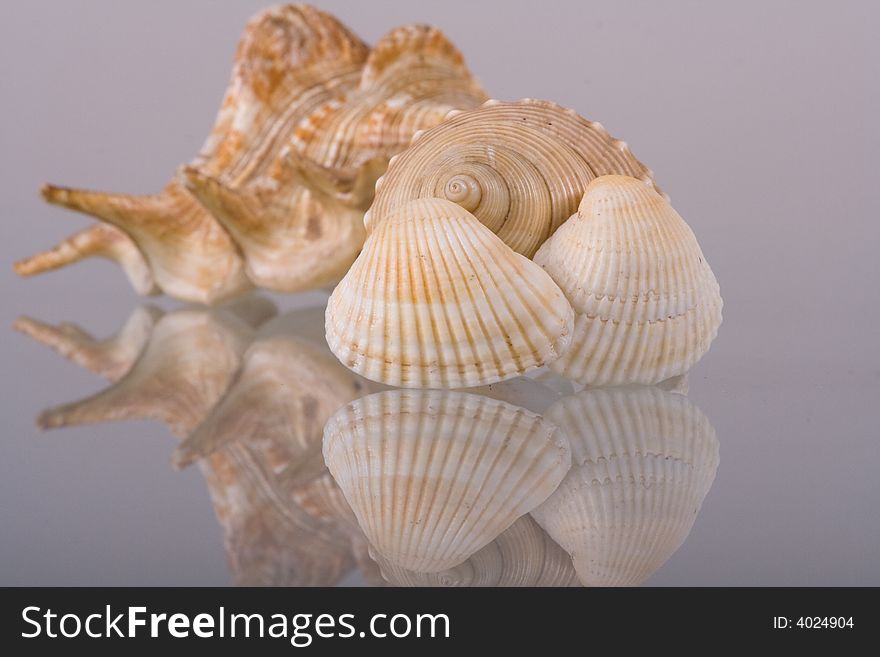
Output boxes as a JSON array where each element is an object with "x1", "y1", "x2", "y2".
[{"x1": 326, "y1": 199, "x2": 572, "y2": 388}]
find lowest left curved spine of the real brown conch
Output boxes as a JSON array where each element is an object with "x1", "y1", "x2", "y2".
[{"x1": 15, "y1": 224, "x2": 160, "y2": 296}]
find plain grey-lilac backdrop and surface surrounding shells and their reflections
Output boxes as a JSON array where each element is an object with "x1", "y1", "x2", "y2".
[{"x1": 0, "y1": 0, "x2": 880, "y2": 585}]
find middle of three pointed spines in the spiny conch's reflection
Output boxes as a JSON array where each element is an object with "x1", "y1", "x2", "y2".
[{"x1": 30, "y1": 300, "x2": 274, "y2": 437}]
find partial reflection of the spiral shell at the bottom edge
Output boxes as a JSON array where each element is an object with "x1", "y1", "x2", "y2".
[{"x1": 371, "y1": 516, "x2": 578, "y2": 587}]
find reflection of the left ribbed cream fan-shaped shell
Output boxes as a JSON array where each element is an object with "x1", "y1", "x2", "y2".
[{"x1": 324, "y1": 390, "x2": 569, "y2": 572}]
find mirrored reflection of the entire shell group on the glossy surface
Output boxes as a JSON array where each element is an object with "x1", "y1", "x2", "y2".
[{"x1": 16, "y1": 297, "x2": 718, "y2": 586}]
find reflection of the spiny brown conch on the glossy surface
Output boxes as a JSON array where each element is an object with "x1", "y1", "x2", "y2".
[{"x1": 17, "y1": 299, "x2": 379, "y2": 586}]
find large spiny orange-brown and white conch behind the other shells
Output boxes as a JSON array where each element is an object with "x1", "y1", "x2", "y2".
[{"x1": 16, "y1": 5, "x2": 486, "y2": 304}]
